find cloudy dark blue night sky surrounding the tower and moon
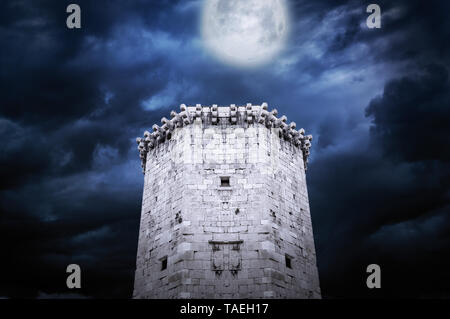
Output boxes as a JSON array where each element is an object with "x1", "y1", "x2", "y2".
[{"x1": 0, "y1": 0, "x2": 450, "y2": 298}]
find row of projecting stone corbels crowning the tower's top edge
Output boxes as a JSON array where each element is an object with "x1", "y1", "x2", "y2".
[{"x1": 136, "y1": 103, "x2": 312, "y2": 174}]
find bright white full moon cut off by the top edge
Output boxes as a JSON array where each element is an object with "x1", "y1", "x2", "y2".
[{"x1": 201, "y1": 0, "x2": 288, "y2": 67}]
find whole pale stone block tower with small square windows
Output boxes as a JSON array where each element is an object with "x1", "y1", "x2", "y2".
[{"x1": 133, "y1": 103, "x2": 321, "y2": 298}]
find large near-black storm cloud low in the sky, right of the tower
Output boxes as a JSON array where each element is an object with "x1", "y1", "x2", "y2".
[{"x1": 309, "y1": 65, "x2": 450, "y2": 297}]
